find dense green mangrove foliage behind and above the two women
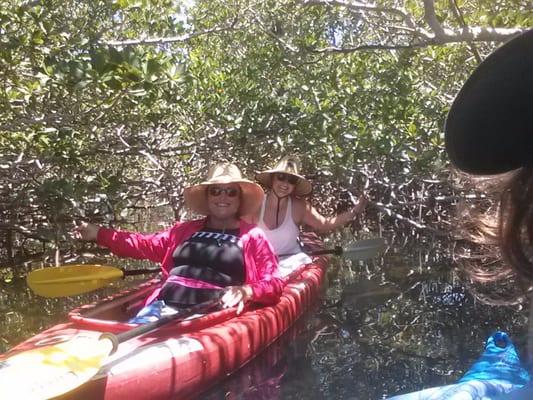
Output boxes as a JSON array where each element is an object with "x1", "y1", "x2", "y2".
[{"x1": 0, "y1": 0, "x2": 533, "y2": 268}]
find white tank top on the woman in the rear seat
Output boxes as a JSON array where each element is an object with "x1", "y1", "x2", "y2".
[{"x1": 257, "y1": 196, "x2": 301, "y2": 255}]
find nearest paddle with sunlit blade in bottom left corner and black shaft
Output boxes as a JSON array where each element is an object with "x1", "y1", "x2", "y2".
[{"x1": 0, "y1": 299, "x2": 219, "y2": 400}]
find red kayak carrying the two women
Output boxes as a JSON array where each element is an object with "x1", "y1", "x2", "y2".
[{"x1": 0, "y1": 241, "x2": 327, "y2": 400}]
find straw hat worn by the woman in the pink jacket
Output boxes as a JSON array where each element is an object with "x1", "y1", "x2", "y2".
[{"x1": 183, "y1": 163, "x2": 265, "y2": 215}]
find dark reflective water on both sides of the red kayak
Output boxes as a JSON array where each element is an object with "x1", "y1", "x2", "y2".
[{"x1": 0, "y1": 238, "x2": 527, "y2": 400}]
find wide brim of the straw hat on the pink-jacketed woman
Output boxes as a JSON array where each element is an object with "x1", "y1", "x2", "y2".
[{"x1": 183, "y1": 179, "x2": 265, "y2": 216}]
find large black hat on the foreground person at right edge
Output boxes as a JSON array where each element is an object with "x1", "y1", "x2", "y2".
[{"x1": 445, "y1": 30, "x2": 533, "y2": 175}]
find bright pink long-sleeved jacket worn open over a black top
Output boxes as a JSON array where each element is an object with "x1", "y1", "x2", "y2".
[{"x1": 97, "y1": 219, "x2": 284, "y2": 304}]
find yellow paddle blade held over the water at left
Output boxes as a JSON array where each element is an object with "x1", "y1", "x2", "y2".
[{"x1": 26, "y1": 264, "x2": 124, "y2": 297}]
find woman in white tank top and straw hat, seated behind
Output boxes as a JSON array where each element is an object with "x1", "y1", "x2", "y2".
[{"x1": 249, "y1": 156, "x2": 367, "y2": 268}]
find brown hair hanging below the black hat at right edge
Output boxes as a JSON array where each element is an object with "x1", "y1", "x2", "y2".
[{"x1": 460, "y1": 167, "x2": 533, "y2": 304}]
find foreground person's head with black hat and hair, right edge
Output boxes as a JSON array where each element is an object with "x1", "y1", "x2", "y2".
[{"x1": 445, "y1": 30, "x2": 533, "y2": 280}]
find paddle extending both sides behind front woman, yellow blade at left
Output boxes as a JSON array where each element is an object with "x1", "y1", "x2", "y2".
[{"x1": 26, "y1": 238, "x2": 385, "y2": 297}]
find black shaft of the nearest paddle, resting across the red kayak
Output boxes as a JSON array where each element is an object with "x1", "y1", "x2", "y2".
[{"x1": 100, "y1": 299, "x2": 220, "y2": 354}]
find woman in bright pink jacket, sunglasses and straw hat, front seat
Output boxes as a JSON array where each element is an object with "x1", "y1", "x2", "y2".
[{"x1": 75, "y1": 163, "x2": 283, "y2": 322}]
